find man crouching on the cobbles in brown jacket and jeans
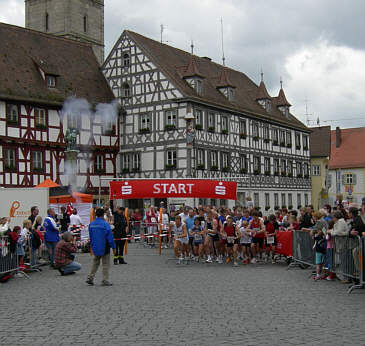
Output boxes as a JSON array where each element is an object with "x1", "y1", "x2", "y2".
[{"x1": 54, "y1": 232, "x2": 81, "y2": 275}]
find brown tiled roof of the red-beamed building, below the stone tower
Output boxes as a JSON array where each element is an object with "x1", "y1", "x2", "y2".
[{"x1": 0, "y1": 23, "x2": 114, "y2": 106}]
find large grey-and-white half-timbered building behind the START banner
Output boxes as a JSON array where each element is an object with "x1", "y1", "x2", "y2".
[{"x1": 102, "y1": 31, "x2": 310, "y2": 210}]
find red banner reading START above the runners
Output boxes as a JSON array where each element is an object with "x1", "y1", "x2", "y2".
[{"x1": 109, "y1": 179, "x2": 237, "y2": 200}]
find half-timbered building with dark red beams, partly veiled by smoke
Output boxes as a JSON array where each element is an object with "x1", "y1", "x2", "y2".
[{"x1": 0, "y1": 23, "x2": 120, "y2": 199}]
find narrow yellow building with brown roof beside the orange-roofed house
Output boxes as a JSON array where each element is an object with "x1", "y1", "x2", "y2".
[{"x1": 310, "y1": 126, "x2": 331, "y2": 210}]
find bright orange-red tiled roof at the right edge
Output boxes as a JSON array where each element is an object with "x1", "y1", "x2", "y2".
[{"x1": 328, "y1": 127, "x2": 365, "y2": 169}]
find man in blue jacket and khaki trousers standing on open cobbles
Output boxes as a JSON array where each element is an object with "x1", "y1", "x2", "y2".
[{"x1": 86, "y1": 208, "x2": 115, "y2": 286}]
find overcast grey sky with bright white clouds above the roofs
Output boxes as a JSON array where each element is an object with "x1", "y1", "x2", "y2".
[{"x1": 0, "y1": 0, "x2": 365, "y2": 127}]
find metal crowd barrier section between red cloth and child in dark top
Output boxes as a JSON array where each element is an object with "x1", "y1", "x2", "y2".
[{"x1": 288, "y1": 231, "x2": 315, "y2": 268}]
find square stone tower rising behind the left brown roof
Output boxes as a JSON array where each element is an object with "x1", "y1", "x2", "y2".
[{"x1": 25, "y1": 0, "x2": 104, "y2": 65}]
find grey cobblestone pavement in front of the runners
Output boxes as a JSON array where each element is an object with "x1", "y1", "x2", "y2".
[{"x1": 0, "y1": 244, "x2": 365, "y2": 346}]
